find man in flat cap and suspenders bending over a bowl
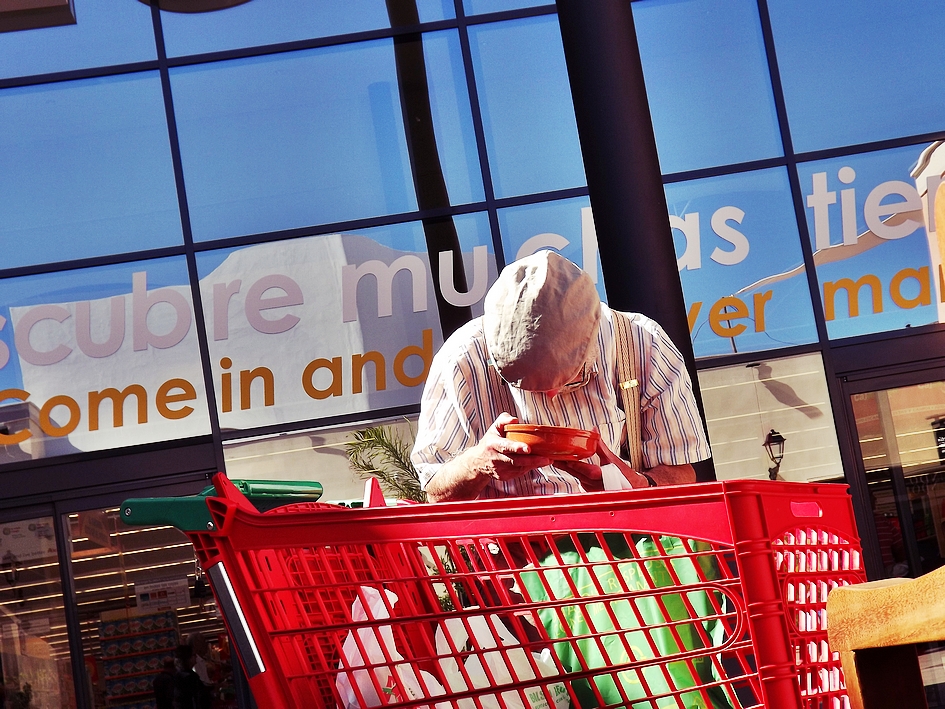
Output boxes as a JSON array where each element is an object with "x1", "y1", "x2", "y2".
[{"x1": 412, "y1": 251, "x2": 710, "y2": 502}]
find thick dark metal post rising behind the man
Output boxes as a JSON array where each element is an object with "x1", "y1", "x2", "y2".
[{"x1": 557, "y1": 0, "x2": 715, "y2": 480}]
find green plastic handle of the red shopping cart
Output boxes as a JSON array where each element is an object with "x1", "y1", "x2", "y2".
[{"x1": 119, "y1": 480, "x2": 322, "y2": 532}]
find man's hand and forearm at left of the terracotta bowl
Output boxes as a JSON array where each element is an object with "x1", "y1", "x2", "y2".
[{"x1": 426, "y1": 413, "x2": 551, "y2": 502}]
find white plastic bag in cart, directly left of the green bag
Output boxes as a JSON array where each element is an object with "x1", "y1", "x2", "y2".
[{"x1": 436, "y1": 609, "x2": 570, "y2": 709}]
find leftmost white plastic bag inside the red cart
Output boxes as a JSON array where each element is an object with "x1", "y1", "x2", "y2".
[{"x1": 335, "y1": 586, "x2": 449, "y2": 709}]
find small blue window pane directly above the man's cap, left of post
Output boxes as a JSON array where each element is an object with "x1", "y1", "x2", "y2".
[{"x1": 499, "y1": 197, "x2": 607, "y2": 303}]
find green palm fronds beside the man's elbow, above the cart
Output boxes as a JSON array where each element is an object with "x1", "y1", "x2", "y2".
[{"x1": 345, "y1": 426, "x2": 427, "y2": 502}]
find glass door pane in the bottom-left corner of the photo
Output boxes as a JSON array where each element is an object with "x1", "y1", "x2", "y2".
[{"x1": 0, "y1": 517, "x2": 76, "y2": 709}]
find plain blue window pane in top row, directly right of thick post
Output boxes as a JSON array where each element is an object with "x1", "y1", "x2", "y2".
[{"x1": 631, "y1": 0, "x2": 782, "y2": 173}]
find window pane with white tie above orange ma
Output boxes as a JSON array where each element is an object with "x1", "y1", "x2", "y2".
[{"x1": 798, "y1": 143, "x2": 945, "y2": 338}]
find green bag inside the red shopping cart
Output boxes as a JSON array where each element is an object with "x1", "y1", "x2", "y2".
[{"x1": 521, "y1": 534, "x2": 738, "y2": 709}]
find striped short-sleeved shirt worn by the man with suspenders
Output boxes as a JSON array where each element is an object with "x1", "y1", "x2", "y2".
[{"x1": 411, "y1": 305, "x2": 711, "y2": 498}]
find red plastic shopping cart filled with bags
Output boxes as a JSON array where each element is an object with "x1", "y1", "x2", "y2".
[{"x1": 122, "y1": 474, "x2": 865, "y2": 709}]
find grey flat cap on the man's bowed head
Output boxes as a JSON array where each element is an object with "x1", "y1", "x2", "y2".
[{"x1": 482, "y1": 251, "x2": 601, "y2": 391}]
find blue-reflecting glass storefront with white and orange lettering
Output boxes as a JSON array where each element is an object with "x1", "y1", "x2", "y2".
[{"x1": 0, "y1": 0, "x2": 945, "y2": 708}]
